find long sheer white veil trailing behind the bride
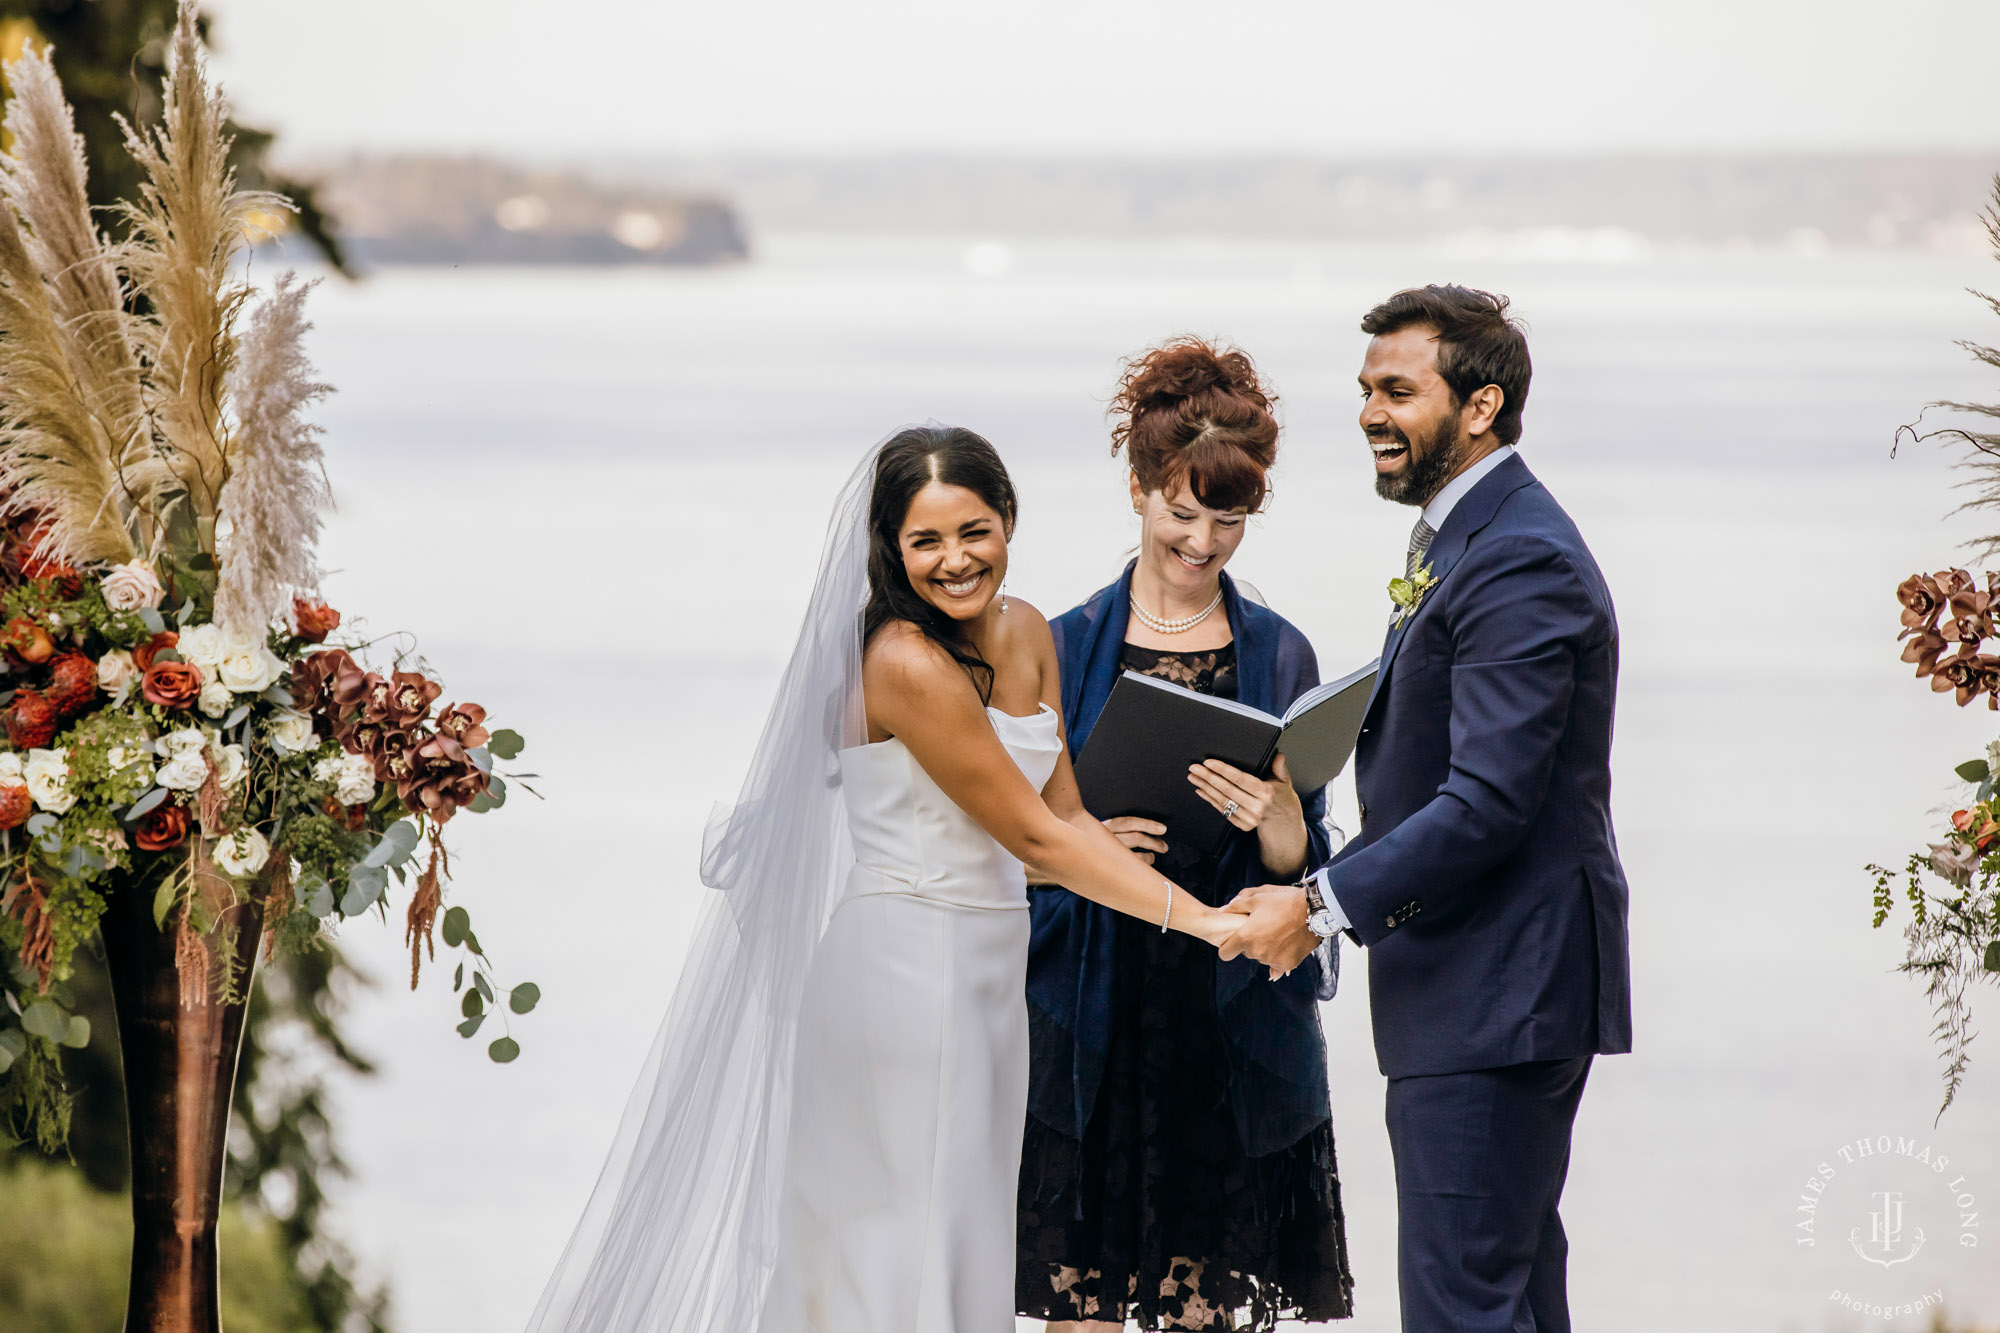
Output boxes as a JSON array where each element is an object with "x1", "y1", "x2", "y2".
[{"x1": 528, "y1": 436, "x2": 894, "y2": 1333}]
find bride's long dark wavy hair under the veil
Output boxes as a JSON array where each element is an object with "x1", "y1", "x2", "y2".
[{"x1": 862, "y1": 426, "x2": 1018, "y2": 703}]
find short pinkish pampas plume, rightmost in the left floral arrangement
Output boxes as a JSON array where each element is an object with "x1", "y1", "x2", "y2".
[{"x1": 216, "y1": 272, "x2": 328, "y2": 632}]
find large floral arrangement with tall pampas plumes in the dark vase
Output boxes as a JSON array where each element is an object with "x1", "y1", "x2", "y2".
[{"x1": 0, "y1": 4, "x2": 538, "y2": 1147}]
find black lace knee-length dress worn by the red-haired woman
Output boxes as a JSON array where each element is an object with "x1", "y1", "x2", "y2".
[{"x1": 1014, "y1": 644, "x2": 1354, "y2": 1331}]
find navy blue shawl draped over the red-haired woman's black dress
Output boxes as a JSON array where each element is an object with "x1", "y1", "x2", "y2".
[{"x1": 1028, "y1": 564, "x2": 1332, "y2": 1157}]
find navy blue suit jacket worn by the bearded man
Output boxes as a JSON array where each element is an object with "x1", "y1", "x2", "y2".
[{"x1": 1328, "y1": 456, "x2": 1632, "y2": 1079}]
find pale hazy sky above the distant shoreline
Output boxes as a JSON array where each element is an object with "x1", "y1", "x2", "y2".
[{"x1": 208, "y1": 0, "x2": 2000, "y2": 156}]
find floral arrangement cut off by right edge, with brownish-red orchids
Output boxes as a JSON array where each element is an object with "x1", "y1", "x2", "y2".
[{"x1": 1868, "y1": 178, "x2": 2000, "y2": 1115}]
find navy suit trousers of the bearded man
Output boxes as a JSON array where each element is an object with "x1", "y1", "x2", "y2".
[{"x1": 1388, "y1": 1055, "x2": 1590, "y2": 1333}]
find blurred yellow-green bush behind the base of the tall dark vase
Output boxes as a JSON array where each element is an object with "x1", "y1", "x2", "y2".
[{"x1": 0, "y1": 1157, "x2": 322, "y2": 1333}]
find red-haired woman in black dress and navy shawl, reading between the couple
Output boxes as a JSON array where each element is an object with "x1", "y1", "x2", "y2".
[{"x1": 1016, "y1": 338, "x2": 1354, "y2": 1333}]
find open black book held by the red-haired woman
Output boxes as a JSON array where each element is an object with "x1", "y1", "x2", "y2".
[{"x1": 1076, "y1": 662, "x2": 1378, "y2": 849}]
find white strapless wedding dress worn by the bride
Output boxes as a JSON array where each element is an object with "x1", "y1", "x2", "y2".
[{"x1": 762, "y1": 705, "x2": 1062, "y2": 1333}]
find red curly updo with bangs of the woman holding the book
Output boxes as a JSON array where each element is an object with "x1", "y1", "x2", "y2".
[{"x1": 1110, "y1": 338, "x2": 1278, "y2": 512}]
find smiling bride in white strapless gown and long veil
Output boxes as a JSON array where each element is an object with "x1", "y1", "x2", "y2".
[{"x1": 530, "y1": 424, "x2": 1242, "y2": 1333}]
